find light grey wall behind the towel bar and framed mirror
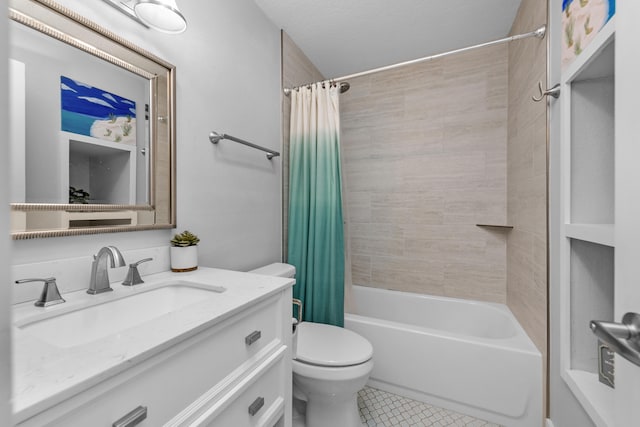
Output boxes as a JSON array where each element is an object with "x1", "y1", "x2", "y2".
[{"x1": 10, "y1": 0, "x2": 281, "y2": 270}]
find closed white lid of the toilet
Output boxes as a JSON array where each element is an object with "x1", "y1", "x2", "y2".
[{"x1": 296, "y1": 322, "x2": 373, "y2": 366}]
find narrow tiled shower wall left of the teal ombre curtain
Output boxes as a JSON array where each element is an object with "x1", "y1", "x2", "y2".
[{"x1": 281, "y1": 31, "x2": 324, "y2": 262}]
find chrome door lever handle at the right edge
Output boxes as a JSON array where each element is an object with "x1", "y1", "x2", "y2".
[{"x1": 589, "y1": 313, "x2": 640, "y2": 366}]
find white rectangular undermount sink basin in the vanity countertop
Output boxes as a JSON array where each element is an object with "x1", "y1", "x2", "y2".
[{"x1": 16, "y1": 281, "x2": 225, "y2": 348}]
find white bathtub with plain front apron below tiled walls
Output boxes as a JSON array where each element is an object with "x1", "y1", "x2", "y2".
[{"x1": 345, "y1": 286, "x2": 543, "y2": 427}]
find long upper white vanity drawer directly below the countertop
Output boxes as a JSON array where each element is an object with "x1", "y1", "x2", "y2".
[{"x1": 20, "y1": 298, "x2": 282, "y2": 427}]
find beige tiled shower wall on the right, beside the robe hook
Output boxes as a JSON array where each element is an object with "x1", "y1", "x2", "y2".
[{"x1": 507, "y1": 0, "x2": 547, "y2": 404}]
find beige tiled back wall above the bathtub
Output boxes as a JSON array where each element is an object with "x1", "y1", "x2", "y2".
[{"x1": 340, "y1": 45, "x2": 508, "y2": 303}]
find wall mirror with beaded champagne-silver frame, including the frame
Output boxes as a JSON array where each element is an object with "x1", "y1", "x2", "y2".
[{"x1": 9, "y1": 0, "x2": 175, "y2": 239}]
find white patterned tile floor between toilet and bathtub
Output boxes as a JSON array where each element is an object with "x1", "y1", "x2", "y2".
[{"x1": 358, "y1": 387, "x2": 500, "y2": 427}]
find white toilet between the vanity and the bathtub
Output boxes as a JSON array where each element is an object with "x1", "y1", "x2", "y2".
[{"x1": 251, "y1": 263, "x2": 373, "y2": 427}]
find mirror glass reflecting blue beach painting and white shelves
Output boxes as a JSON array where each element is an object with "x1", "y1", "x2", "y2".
[{"x1": 9, "y1": 22, "x2": 150, "y2": 205}]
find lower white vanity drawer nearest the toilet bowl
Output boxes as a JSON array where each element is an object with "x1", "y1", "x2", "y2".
[{"x1": 174, "y1": 347, "x2": 289, "y2": 427}]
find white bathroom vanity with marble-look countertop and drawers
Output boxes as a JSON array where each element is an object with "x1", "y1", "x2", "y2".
[{"x1": 13, "y1": 268, "x2": 294, "y2": 427}]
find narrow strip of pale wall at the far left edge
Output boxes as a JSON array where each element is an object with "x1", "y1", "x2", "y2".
[{"x1": 0, "y1": 0, "x2": 11, "y2": 426}]
